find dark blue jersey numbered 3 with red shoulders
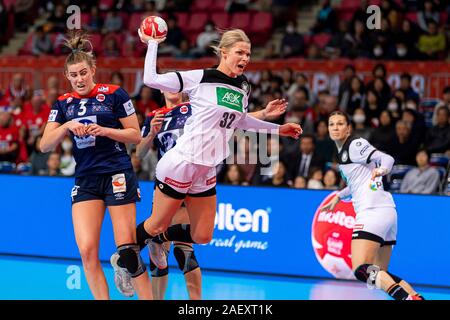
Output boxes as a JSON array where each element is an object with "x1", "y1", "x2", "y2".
[{"x1": 48, "y1": 84, "x2": 135, "y2": 177}]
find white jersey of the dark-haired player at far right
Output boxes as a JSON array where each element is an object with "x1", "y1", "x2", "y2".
[{"x1": 338, "y1": 136, "x2": 395, "y2": 213}]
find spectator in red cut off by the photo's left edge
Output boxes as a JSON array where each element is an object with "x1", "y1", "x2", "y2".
[{"x1": 0, "y1": 111, "x2": 19, "y2": 163}]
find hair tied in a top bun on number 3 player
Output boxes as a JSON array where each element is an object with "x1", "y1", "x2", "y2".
[{"x1": 64, "y1": 30, "x2": 95, "y2": 72}]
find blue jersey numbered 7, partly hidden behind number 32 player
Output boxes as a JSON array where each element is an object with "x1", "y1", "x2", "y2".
[{"x1": 141, "y1": 103, "x2": 192, "y2": 160}]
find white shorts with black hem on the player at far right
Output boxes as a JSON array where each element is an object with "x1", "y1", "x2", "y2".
[{"x1": 352, "y1": 207, "x2": 397, "y2": 246}]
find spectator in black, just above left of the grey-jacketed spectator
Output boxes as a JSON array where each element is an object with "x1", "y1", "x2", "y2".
[{"x1": 391, "y1": 120, "x2": 419, "y2": 166}]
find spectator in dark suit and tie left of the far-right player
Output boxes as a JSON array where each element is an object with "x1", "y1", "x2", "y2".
[{"x1": 287, "y1": 134, "x2": 325, "y2": 181}]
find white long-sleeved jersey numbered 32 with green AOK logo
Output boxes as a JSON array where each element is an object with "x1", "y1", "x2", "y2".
[{"x1": 144, "y1": 40, "x2": 278, "y2": 167}]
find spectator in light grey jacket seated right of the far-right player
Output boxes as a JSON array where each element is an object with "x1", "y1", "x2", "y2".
[{"x1": 400, "y1": 149, "x2": 440, "y2": 194}]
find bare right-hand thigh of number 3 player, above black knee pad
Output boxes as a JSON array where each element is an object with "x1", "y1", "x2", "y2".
[{"x1": 108, "y1": 203, "x2": 136, "y2": 246}]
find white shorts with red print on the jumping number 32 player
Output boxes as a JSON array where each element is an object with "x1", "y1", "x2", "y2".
[{"x1": 156, "y1": 149, "x2": 216, "y2": 199}]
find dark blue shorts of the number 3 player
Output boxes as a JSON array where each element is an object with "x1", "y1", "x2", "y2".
[{"x1": 71, "y1": 169, "x2": 141, "y2": 206}]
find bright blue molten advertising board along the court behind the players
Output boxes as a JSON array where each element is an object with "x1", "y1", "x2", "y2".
[{"x1": 0, "y1": 175, "x2": 450, "y2": 286}]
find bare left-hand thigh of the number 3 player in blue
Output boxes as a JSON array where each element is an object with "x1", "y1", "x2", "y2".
[{"x1": 72, "y1": 200, "x2": 105, "y2": 252}]
